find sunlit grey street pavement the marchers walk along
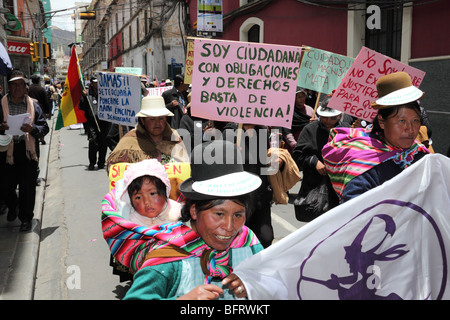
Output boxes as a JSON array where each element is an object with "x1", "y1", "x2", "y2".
[{"x1": 34, "y1": 123, "x2": 304, "y2": 300}]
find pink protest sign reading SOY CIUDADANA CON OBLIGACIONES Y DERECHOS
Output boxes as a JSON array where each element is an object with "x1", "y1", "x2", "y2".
[{"x1": 191, "y1": 39, "x2": 302, "y2": 128}]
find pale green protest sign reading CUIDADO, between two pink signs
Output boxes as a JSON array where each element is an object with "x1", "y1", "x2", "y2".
[{"x1": 297, "y1": 47, "x2": 355, "y2": 94}]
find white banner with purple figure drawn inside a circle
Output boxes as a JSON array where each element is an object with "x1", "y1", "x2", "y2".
[{"x1": 234, "y1": 154, "x2": 450, "y2": 300}]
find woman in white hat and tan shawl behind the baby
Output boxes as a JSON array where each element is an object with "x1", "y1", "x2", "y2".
[{"x1": 107, "y1": 96, "x2": 189, "y2": 171}]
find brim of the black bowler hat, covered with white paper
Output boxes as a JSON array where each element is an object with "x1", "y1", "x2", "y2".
[{"x1": 179, "y1": 171, "x2": 262, "y2": 200}]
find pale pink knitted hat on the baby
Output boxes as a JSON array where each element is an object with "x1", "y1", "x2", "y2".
[{"x1": 120, "y1": 159, "x2": 170, "y2": 202}]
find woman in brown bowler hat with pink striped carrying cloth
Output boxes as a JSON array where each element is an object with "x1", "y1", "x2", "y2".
[{"x1": 322, "y1": 72, "x2": 429, "y2": 203}]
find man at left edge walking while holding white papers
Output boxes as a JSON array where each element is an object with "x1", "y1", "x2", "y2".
[{"x1": 0, "y1": 71, "x2": 49, "y2": 231}]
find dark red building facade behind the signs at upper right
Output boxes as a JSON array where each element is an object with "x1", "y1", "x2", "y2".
[{"x1": 189, "y1": 0, "x2": 450, "y2": 153}]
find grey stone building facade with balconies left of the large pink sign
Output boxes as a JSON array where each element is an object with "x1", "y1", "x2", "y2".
[{"x1": 82, "y1": 0, "x2": 186, "y2": 80}]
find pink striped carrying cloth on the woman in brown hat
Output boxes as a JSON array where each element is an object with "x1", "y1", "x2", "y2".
[{"x1": 322, "y1": 127, "x2": 429, "y2": 198}]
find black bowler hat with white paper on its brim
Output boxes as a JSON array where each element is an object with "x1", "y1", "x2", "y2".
[{"x1": 179, "y1": 140, "x2": 261, "y2": 200}]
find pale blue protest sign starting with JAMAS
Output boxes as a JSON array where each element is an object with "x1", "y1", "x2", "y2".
[{"x1": 98, "y1": 72, "x2": 141, "y2": 126}]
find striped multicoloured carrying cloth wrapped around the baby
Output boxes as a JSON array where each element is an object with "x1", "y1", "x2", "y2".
[{"x1": 102, "y1": 193, "x2": 259, "y2": 283}]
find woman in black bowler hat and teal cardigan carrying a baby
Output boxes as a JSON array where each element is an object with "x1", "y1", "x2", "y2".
[{"x1": 103, "y1": 140, "x2": 263, "y2": 300}]
